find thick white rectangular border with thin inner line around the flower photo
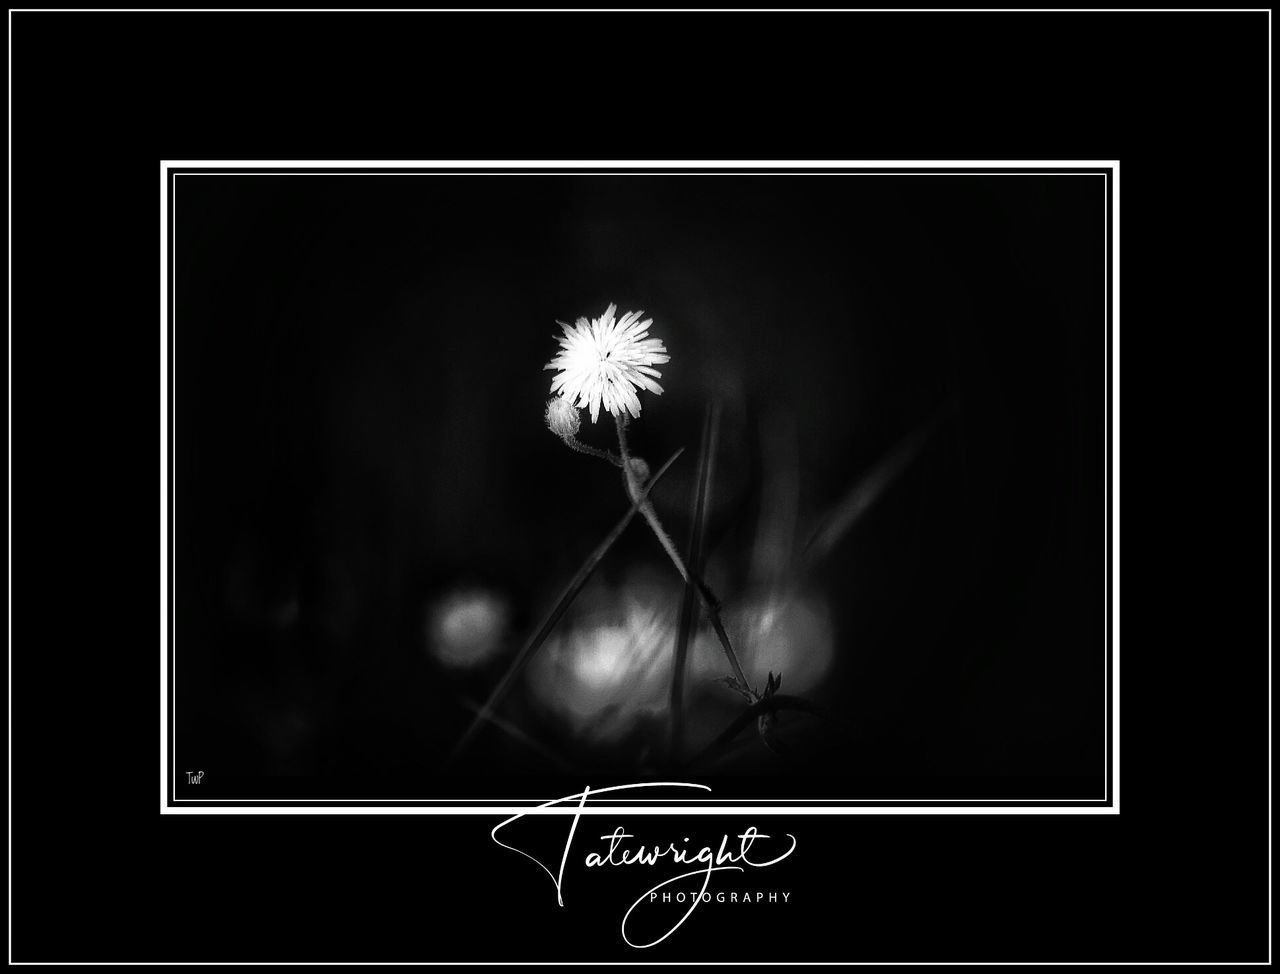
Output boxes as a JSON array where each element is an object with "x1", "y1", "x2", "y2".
[{"x1": 160, "y1": 160, "x2": 1120, "y2": 815}]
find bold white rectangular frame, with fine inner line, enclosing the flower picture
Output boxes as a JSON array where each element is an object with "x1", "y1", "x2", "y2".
[{"x1": 157, "y1": 160, "x2": 1120, "y2": 815}]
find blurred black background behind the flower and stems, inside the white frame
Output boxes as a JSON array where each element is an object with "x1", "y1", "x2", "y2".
[{"x1": 172, "y1": 173, "x2": 1108, "y2": 800}]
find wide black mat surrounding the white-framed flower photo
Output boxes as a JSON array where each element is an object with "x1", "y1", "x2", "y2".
[{"x1": 9, "y1": 13, "x2": 1270, "y2": 961}]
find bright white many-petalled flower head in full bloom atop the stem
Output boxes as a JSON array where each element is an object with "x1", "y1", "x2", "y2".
[{"x1": 543, "y1": 305, "x2": 671, "y2": 422}]
